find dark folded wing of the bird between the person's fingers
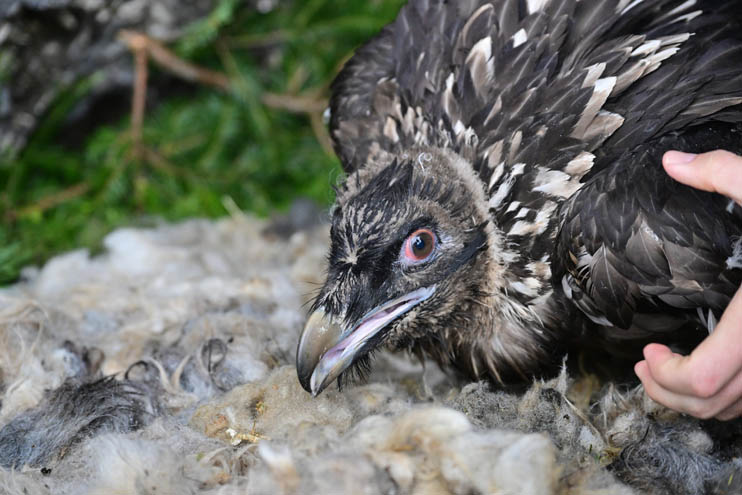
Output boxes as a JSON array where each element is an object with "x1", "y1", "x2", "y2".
[{"x1": 552, "y1": 128, "x2": 742, "y2": 337}]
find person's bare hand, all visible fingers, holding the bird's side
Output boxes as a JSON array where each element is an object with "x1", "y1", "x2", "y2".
[{"x1": 634, "y1": 150, "x2": 742, "y2": 420}]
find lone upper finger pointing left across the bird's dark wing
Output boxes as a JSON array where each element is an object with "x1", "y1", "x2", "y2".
[{"x1": 662, "y1": 150, "x2": 742, "y2": 203}]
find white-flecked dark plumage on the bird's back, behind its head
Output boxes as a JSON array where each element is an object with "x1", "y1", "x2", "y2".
[{"x1": 330, "y1": 0, "x2": 742, "y2": 303}]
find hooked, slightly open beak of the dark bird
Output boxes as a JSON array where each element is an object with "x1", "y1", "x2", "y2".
[{"x1": 296, "y1": 287, "x2": 435, "y2": 396}]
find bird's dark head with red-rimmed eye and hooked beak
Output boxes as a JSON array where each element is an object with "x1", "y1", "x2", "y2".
[{"x1": 296, "y1": 149, "x2": 500, "y2": 395}]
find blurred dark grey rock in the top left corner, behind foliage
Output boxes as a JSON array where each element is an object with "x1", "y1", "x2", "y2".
[{"x1": 0, "y1": 0, "x2": 215, "y2": 153}]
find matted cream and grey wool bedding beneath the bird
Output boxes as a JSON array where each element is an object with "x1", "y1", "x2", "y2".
[{"x1": 0, "y1": 216, "x2": 742, "y2": 495}]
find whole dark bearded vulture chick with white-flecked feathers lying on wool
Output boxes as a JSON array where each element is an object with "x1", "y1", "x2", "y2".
[{"x1": 297, "y1": 0, "x2": 742, "y2": 395}]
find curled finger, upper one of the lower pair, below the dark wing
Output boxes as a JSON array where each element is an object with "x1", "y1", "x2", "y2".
[{"x1": 644, "y1": 289, "x2": 742, "y2": 397}]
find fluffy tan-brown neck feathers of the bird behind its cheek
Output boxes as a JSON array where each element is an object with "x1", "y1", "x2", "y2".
[{"x1": 422, "y1": 150, "x2": 559, "y2": 382}]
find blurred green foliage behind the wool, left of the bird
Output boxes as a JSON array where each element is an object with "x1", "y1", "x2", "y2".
[{"x1": 0, "y1": 0, "x2": 403, "y2": 283}]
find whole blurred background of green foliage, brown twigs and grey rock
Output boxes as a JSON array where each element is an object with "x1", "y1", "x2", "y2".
[{"x1": 0, "y1": 0, "x2": 404, "y2": 284}]
